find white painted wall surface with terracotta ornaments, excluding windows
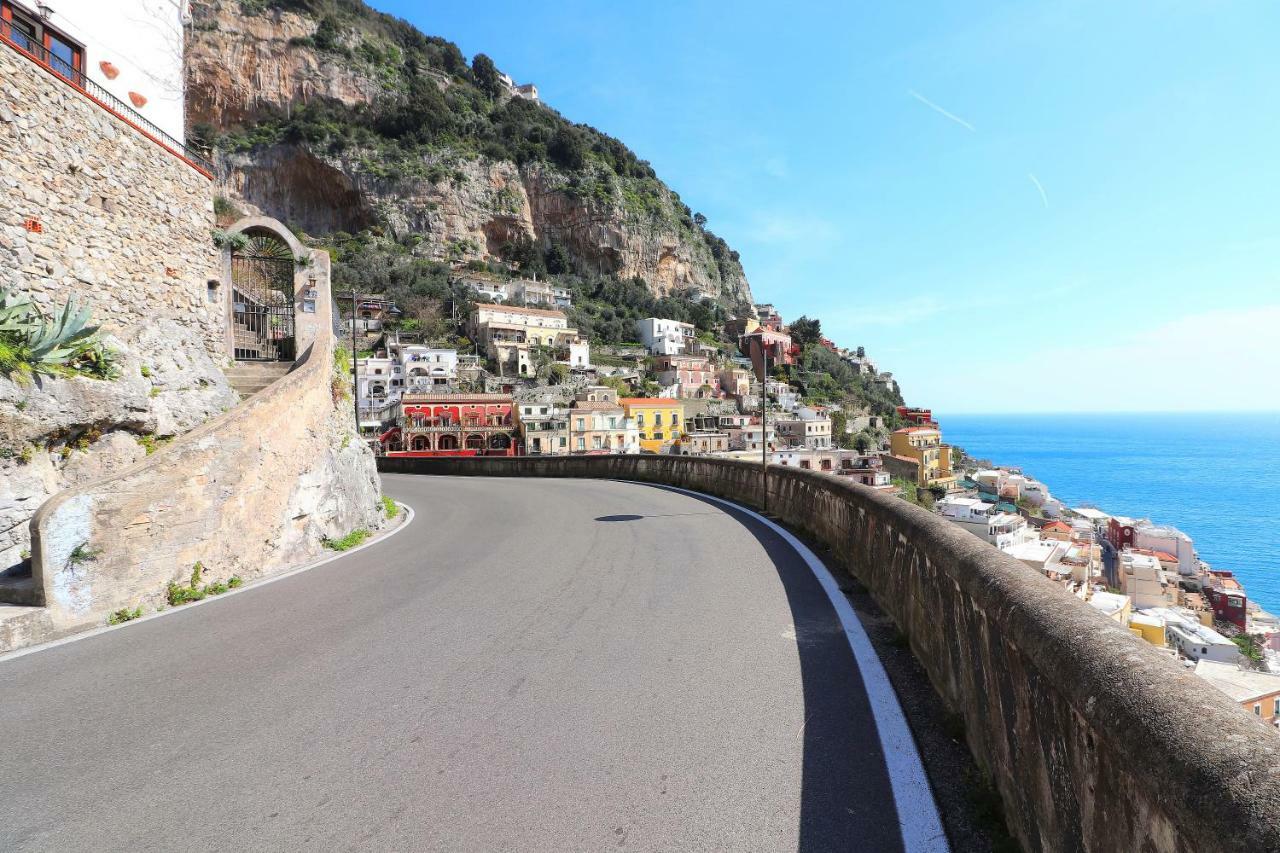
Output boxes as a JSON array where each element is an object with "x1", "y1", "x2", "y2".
[{"x1": 40, "y1": 0, "x2": 189, "y2": 142}]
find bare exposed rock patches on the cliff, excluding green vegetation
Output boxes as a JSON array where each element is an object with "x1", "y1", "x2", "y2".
[{"x1": 187, "y1": 0, "x2": 753, "y2": 306}]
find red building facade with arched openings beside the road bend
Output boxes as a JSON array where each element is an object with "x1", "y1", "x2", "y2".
[{"x1": 381, "y1": 394, "x2": 518, "y2": 456}]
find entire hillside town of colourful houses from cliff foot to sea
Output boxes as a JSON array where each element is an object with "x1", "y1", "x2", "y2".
[{"x1": 339, "y1": 286, "x2": 1280, "y2": 729}]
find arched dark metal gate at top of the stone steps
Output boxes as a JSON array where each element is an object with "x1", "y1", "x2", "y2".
[{"x1": 232, "y1": 237, "x2": 297, "y2": 361}]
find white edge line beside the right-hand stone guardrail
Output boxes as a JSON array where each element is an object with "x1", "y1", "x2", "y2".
[{"x1": 645, "y1": 483, "x2": 951, "y2": 853}]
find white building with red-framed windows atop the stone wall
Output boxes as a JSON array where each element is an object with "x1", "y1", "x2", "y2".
[{"x1": 21, "y1": 0, "x2": 191, "y2": 145}]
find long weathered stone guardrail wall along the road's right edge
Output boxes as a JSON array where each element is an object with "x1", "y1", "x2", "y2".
[{"x1": 378, "y1": 456, "x2": 1280, "y2": 853}]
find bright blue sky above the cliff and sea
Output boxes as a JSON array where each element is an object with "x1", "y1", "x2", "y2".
[{"x1": 374, "y1": 0, "x2": 1280, "y2": 412}]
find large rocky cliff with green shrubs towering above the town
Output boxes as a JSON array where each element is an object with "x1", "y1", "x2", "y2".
[{"x1": 186, "y1": 0, "x2": 753, "y2": 309}]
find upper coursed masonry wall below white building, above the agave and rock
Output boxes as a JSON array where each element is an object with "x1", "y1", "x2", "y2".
[{"x1": 0, "y1": 45, "x2": 227, "y2": 362}]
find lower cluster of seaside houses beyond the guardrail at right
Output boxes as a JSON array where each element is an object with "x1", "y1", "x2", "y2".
[{"x1": 931, "y1": 432, "x2": 1280, "y2": 729}]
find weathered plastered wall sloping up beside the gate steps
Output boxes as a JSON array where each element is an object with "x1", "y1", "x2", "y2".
[{"x1": 16, "y1": 245, "x2": 380, "y2": 651}]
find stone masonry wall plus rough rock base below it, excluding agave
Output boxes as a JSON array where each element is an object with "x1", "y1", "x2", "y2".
[{"x1": 0, "y1": 44, "x2": 238, "y2": 571}]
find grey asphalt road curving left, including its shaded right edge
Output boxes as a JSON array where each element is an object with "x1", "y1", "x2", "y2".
[{"x1": 0, "y1": 476, "x2": 921, "y2": 853}]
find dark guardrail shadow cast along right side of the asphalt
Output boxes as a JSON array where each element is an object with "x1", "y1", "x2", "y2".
[{"x1": 627, "y1": 483, "x2": 902, "y2": 853}]
